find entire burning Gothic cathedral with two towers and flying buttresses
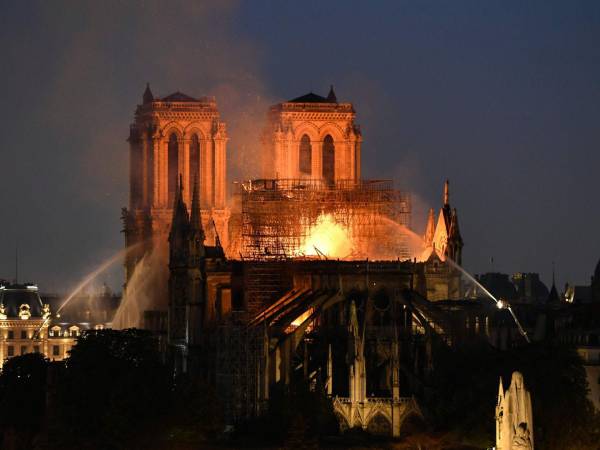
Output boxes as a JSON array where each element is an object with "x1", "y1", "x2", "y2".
[{"x1": 122, "y1": 86, "x2": 468, "y2": 436}]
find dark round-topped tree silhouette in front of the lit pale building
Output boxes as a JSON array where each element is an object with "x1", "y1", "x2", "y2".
[{"x1": 44, "y1": 329, "x2": 171, "y2": 449}]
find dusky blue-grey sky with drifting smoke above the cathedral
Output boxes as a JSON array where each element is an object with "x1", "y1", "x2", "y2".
[{"x1": 0, "y1": 0, "x2": 600, "y2": 291}]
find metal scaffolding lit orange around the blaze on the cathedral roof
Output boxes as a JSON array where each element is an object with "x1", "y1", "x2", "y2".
[{"x1": 239, "y1": 179, "x2": 411, "y2": 261}]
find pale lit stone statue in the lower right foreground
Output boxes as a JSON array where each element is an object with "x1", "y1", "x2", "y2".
[{"x1": 496, "y1": 372, "x2": 533, "y2": 450}]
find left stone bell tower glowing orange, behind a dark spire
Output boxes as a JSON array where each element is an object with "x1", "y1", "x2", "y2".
[{"x1": 123, "y1": 85, "x2": 230, "y2": 282}]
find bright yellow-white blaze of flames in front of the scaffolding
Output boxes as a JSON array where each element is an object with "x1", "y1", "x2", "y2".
[{"x1": 301, "y1": 214, "x2": 352, "y2": 258}]
